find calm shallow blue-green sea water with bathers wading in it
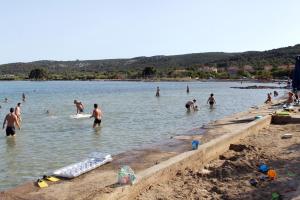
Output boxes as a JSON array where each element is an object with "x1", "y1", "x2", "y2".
[{"x1": 0, "y1": 81, "x2": 278, "y2": 190}]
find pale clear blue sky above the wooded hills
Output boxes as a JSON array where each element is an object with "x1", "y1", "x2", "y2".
[{"x1": 0, "y1": 0, "x2": 300, "y2": 64}]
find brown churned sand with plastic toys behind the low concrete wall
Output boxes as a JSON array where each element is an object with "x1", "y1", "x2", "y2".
[{"x1": 136, "y1": 124, "x2": 300, "y2": 200}]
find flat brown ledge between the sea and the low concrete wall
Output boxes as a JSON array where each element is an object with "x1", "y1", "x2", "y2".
[{"x1": 0, "y1": 99, "x2": 290, "y2": 200}]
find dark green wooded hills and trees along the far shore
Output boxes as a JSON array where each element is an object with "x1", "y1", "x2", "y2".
[{"x1": 0, "y1": 44, "x2": 300, "y2": 81}]
